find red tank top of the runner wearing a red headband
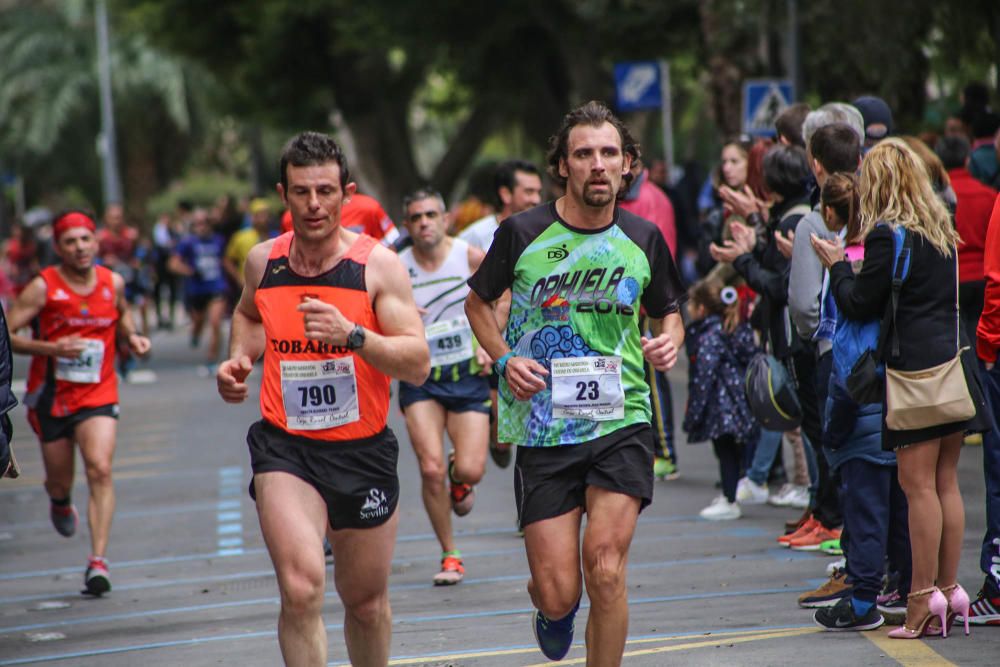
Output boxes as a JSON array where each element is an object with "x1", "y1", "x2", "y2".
[{"x1": 25, "y1": 266, "x2": 119, "y2": 417}]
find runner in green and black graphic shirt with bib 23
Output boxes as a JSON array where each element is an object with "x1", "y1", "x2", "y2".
[{"x1": 466, "y1": 102, "x2": 684, "y2": 665}]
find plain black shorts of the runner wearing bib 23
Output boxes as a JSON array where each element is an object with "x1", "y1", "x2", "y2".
[{"x1": 514, "y1": 424, "x2": 655, "y2": 529}]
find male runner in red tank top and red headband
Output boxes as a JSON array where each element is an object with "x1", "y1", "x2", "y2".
[{"x1": 7, "y1": 211, "x2": 150, "y2": 595}]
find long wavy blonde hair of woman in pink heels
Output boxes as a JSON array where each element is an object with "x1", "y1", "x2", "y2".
[{"x1": 859, "y1": 138, "x2": 961, "y2": 257}]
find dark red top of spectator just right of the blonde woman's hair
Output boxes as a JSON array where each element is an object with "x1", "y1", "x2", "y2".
[{"x1": 948, "y1": 167, "x2": 997, "y2": 283}]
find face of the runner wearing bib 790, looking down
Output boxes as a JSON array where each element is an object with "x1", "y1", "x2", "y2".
[{"x1": 278, "y1": 162, "x2": 354, "y2": 241}]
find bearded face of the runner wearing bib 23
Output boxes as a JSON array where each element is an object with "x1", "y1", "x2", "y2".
[{"x1": 559, "y1": 123, "x2": 631, "y2": 208}]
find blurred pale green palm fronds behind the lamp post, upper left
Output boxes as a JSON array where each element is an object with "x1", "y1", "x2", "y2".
[{"x1": 0, "y1": 0, "x2": 203, "y2": 219}]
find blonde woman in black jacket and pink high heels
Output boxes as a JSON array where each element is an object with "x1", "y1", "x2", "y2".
[{"x1": 812, "y1": 139, "x2": 989, "y2": 639}]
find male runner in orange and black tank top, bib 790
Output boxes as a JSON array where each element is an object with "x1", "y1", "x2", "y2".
[{"x1": 217, "y1": 132, "x2": 430, "y2": 666}]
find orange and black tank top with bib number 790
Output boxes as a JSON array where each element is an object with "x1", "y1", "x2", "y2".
[{"x1": 254, "y1": 232, "x2": 389, "y2": 442}]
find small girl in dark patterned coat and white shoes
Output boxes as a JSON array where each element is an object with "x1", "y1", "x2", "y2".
[{"x1": 684, "y1": 278, "x2": 758, "y2": 521}]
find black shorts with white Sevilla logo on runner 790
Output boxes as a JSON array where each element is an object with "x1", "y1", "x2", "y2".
[{"x1": 247, "y1": 420, "x2": 399, "y2": 530}]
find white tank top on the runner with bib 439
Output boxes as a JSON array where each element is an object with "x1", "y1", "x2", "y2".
[{"x1": 399, "y1": 239, "x2": 475, "y2": 370}]
